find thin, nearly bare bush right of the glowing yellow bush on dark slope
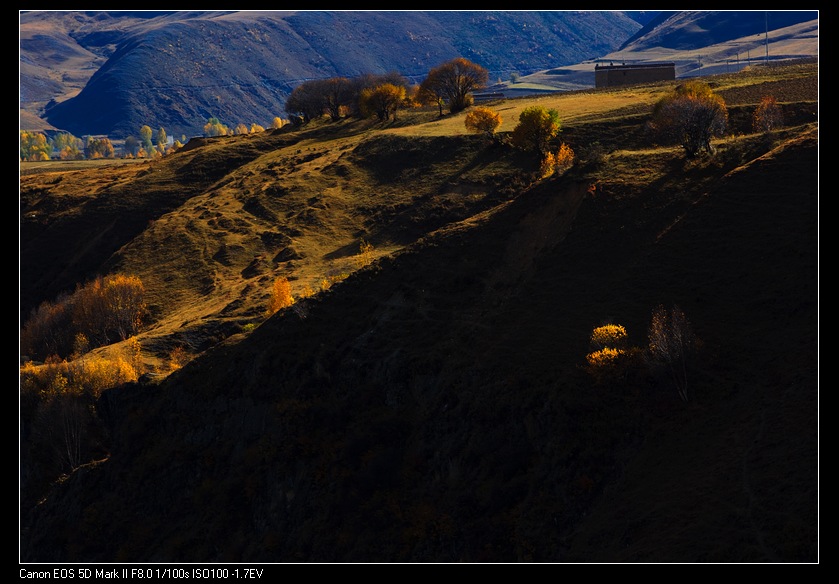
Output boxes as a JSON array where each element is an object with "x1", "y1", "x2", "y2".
[{"x1": 646, "y1": 305, "x2": 696, "y2": 401}]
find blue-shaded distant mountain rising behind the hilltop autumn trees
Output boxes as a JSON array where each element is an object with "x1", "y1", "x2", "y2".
[{"x1": 21, "y1": 11, "x2": 641, "y2": 138}]
